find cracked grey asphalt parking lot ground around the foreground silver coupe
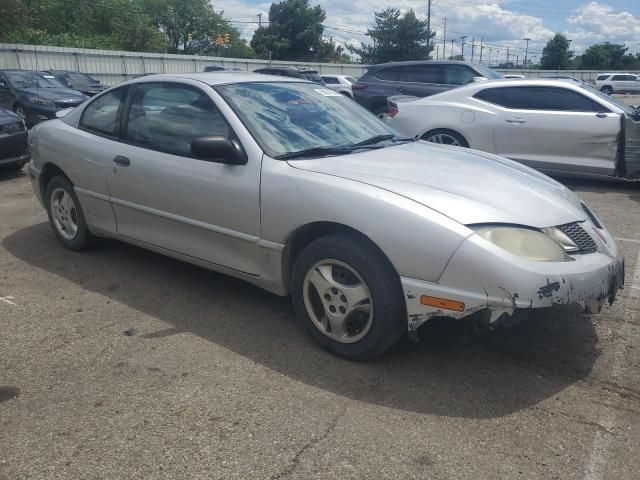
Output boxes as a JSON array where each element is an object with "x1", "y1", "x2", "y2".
[{"x1": 0, "y1": 167, "x2": 640, "y2": 480}]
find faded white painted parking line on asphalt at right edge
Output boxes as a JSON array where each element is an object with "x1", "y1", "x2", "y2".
[{"x1": 584, "y1": 248, "x2": 640, "y2": 480}]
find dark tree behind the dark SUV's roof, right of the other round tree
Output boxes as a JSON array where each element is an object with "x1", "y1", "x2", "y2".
[{"x1": 347, "y1": 8, "x2": 435, "y2": 63}]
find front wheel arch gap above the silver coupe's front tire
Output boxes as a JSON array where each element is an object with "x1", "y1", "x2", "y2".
[{"x1": 282, "y1": 221, "x2": 400, "y2": 292}]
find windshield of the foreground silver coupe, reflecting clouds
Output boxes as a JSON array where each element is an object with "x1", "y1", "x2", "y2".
[{"x1": 216, "y1": 82, "x2": 399, "y2": 158}]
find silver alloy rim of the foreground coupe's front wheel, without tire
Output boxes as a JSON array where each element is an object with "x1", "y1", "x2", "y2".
[{"x1": 303, "y1": 259, "x2": 373, "y2": 343}]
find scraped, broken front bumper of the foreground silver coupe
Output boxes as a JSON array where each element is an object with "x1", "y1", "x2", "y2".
[{"x1": 401, "y1": 223, "x2": 624, "y2": 332}]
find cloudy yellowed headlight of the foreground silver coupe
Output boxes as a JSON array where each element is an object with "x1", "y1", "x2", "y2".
[{"x1": 474, "y1": 226, "x2": 573, "y2": 262}]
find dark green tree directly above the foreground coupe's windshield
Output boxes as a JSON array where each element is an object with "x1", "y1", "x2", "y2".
[{"x1": 251, "y1": 0, "x2": 335, "y2": 61}]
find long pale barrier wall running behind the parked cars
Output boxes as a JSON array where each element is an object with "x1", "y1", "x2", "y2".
[{"x1": 0, "y1": 43, "x2": 640, "y2": 85}]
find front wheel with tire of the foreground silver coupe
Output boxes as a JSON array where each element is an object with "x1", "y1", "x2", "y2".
[{"x1": 291, "y1": 234, "x2": 407, "y2": 360}]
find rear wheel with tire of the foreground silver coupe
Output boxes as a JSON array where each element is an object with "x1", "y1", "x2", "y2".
[{"x1": 45, "y1": 177, "x2": 93, "y2": 250}]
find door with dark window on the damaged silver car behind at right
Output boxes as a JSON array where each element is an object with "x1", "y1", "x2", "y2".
[{"x1": 475, "y1": 86, "x2": 620, "y2": 175}]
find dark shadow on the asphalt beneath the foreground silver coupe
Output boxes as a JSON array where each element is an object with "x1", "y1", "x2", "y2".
[{"x1": 2, "y1": 223, "x2": 599, "y2": 418}]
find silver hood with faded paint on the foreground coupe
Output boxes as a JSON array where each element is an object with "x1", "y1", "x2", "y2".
[{"x1": 289, "y1": 141, "x2": 586, "y2": 228}]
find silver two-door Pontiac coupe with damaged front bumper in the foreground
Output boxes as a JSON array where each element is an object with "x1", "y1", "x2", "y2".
[{"x1": 28, "y1": 72, "x2": 623, "y2": 359}]
